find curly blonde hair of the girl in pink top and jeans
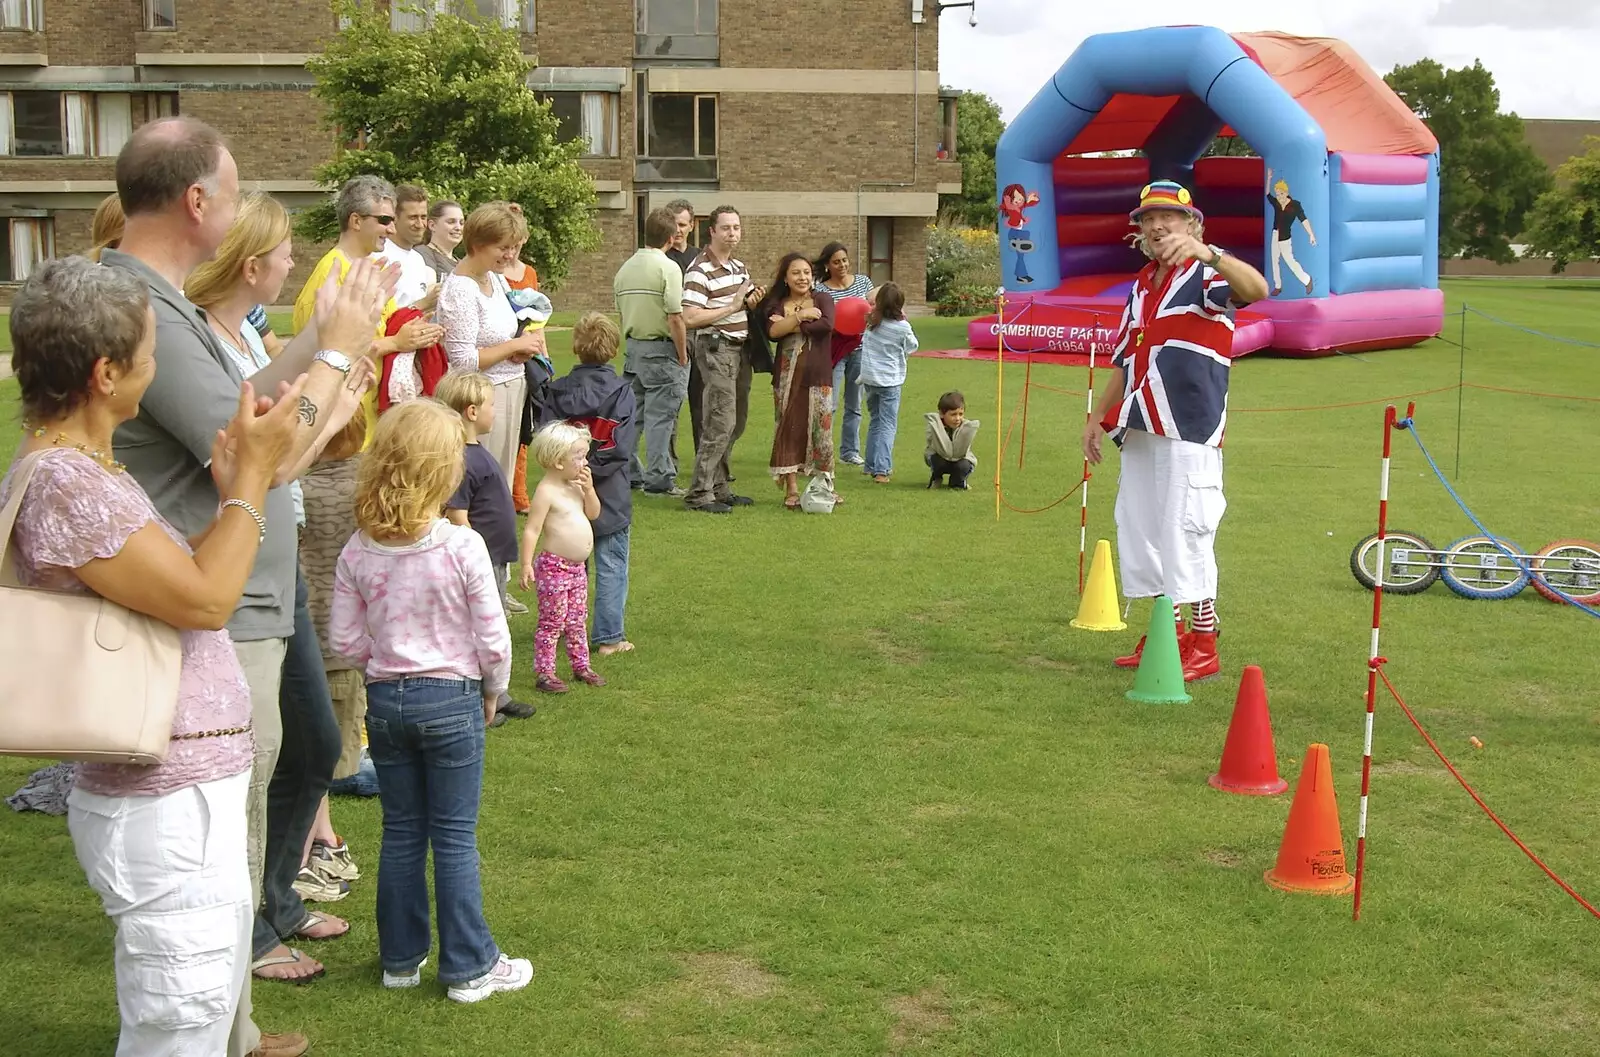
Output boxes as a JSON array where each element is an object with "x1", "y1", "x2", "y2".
[{"x1": 355, "y1": 400, "x2": 467, "y2": 542}]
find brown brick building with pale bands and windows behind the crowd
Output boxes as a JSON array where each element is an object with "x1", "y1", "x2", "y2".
[{"x1": 0, "y1": 0, "x2": 960, "y2": 309}]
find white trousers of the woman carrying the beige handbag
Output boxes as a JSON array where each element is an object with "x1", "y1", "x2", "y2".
[{"x1": 67, "y1": 771, "x2": 254, "y2": 1057}]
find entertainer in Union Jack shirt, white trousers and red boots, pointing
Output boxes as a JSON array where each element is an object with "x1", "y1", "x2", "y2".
[{"x1": 1083, "y1": 181, "x2": 1267, "y2": 681}]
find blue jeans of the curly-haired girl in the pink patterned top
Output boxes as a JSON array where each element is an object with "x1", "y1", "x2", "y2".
[{"x1": 366, "y1": 678, "x2": 499, "y2": 983}]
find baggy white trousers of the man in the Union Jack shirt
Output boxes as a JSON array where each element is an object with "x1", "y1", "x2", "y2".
[{"x1": 1117, "y1": 430, "x2": 1227, "y2": 603}]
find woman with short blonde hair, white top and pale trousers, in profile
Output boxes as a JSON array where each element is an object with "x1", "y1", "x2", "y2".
[{"x1": 438, "y1": 201, "x2": 544, "y2": 481}]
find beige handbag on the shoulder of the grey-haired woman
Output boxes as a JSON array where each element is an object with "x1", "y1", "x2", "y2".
[{"x1": 0, "y1": 451, "x2": 182, "y2": 764}]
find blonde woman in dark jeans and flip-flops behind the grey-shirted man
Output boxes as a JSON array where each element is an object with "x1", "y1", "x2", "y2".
[{"x1": 184, "y1": 193, "x2": 380, "y2": 982}]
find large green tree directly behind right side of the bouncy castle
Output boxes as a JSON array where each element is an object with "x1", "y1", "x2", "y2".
[{"x1": 1384, "y1": 59, "x2": 1550, "y2": 262}]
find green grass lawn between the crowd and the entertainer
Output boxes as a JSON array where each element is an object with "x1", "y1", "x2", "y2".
[{"x1": 0, "y1": 281, "x2": 1600, "y2": 1057}]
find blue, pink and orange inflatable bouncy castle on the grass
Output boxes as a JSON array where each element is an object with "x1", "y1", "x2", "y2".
[{"x1": 968, "y1": 26, "x2": 1445, "y2": 357}]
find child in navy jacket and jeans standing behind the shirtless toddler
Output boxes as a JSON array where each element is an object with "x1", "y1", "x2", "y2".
[{"x1": 539, "y1": 312, "x2": 638, "y2": 657}]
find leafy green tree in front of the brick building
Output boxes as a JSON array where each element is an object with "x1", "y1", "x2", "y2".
[{"x1": 299, "y1": 0, "x2": 600, "y2": 286}]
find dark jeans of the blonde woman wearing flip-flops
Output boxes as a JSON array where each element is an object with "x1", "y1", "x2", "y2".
[{"x1": 251, "y1": 577, "x2": 344, "y2": 958}]
